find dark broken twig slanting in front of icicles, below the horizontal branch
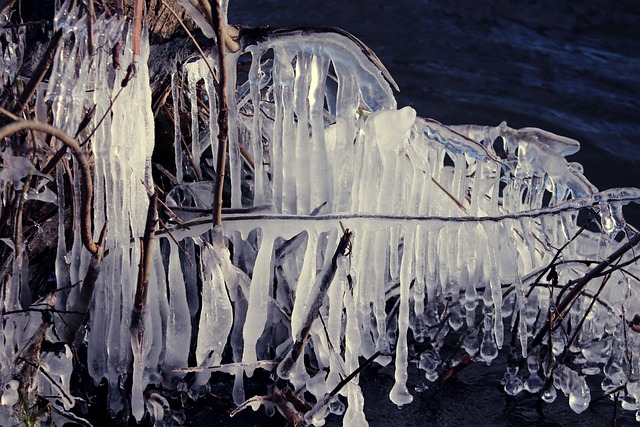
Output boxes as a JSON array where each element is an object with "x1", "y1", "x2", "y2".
[{"x1": 278, "y1": 229, "x2": 353, "y2": 379}]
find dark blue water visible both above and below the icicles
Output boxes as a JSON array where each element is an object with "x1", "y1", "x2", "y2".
[{"x1": 185, "y1": 0, "x2": 640, "y2": 427}]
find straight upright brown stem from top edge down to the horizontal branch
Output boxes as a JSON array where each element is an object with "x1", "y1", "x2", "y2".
[{"x1": 211, "y1": 0, "x2": 229, "y2": 227}]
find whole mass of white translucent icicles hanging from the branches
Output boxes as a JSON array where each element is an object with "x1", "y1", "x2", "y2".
[{"x1": 0, "y1": 3, "x2": 640, "y2": 426}]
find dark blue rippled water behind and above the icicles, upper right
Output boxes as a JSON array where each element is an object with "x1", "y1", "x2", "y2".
[{"x1": 229, "y1": 0, "x2": 640, "y2": 226}]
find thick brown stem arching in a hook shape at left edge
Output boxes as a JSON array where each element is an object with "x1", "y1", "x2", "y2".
[{"x1": 0, "y1": 120, "x2": 99, "y2": 255}]
